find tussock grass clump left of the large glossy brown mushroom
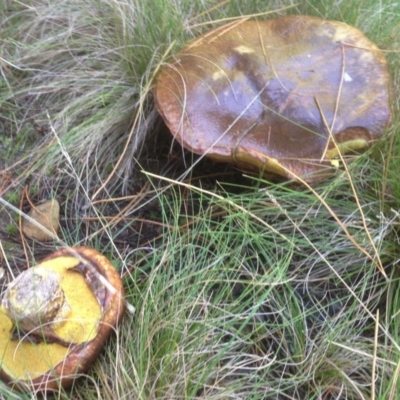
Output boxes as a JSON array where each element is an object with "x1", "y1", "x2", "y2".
[{"x1": 0, "y1": 0, "x2": 194, "y2": 188}]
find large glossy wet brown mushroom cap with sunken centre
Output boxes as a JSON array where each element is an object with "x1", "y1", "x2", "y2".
[{"x1": 154, "y1": 15, "x2": 391, "y2": 182}]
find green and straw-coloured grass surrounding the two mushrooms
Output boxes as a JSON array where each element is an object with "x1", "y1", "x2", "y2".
[{"x1": 0, "y1": 0, "x2": 400, "y2": 400}]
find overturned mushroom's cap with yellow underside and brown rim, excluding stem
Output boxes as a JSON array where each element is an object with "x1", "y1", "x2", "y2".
[{"x1": 0, "y1": 247, "x2": 124, "y2": 392}]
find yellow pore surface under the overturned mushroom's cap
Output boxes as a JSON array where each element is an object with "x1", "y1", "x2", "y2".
[{"x1": 0, "y1": 256, "x2": 102, "y2": 381}]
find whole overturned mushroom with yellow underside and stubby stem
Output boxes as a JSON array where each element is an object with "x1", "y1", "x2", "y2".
[{"x1": 0, "y1": 247, "x2": 125, "y2": 392}]
